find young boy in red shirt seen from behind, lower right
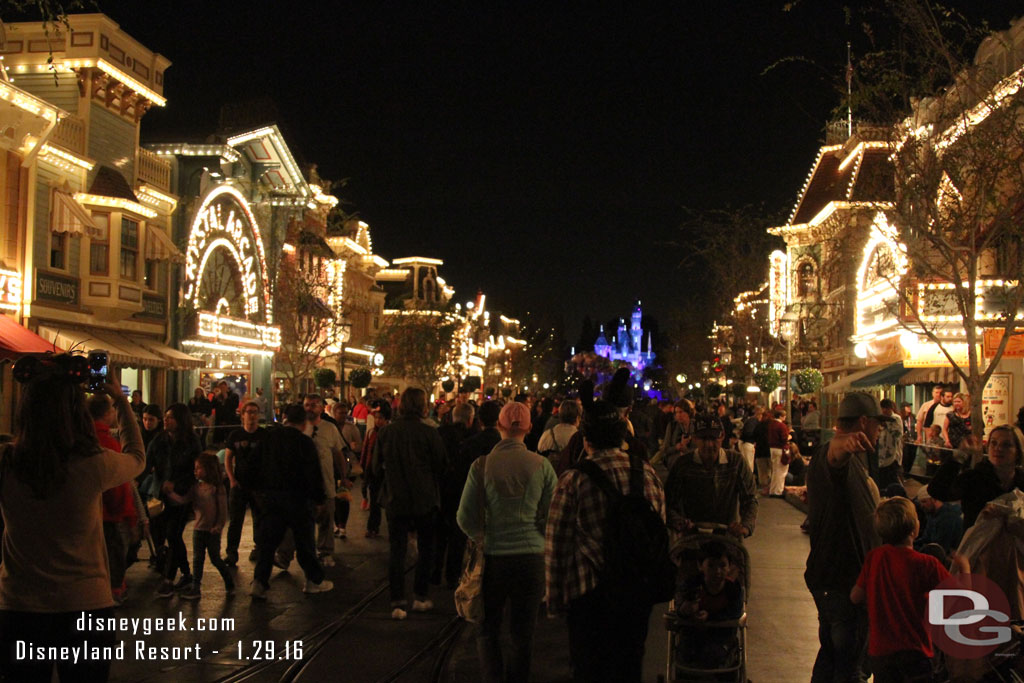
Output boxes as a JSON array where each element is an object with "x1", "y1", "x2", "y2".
[{"x1": 850, "y1": 497, "x2": 971, "y2": 683}]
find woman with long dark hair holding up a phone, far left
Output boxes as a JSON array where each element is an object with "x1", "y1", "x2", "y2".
[{"x1": 0, "y1": 354, "x2": 144, "y2": 681}]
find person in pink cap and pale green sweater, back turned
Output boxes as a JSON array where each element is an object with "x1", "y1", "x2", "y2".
[{"x1": 457, "y1": 402, "x2": 556, "y2": 683}]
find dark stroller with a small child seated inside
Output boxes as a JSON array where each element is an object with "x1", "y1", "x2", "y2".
[{"x1": 665, "y1": 523, "x2": 751, "y2": 683}]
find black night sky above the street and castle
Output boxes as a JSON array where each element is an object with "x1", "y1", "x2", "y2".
[{"x1": 86, "y1": 0, "x2": 1009, "y2": 340}]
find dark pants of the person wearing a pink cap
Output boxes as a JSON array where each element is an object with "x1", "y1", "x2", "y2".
[{"x1": 476, "y1": 553, "x2": 544, "y2": 683}]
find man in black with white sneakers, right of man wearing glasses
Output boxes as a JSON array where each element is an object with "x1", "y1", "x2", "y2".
[{"x1": 252, "y1": 404, "x2": 334, "y2": 599}]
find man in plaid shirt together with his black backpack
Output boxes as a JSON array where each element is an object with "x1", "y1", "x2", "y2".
[{"x1": 545, "y1": 400, "x2": 675, "y2": 683}]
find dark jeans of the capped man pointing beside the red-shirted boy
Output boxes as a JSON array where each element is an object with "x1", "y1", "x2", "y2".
[{"x1": 811, "y1": 590, "x2": 867, "y2": 683}]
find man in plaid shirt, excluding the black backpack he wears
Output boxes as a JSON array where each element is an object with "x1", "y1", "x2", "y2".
[{"x1": 545, "y1": 400, "x2": 665, "y2": 682}]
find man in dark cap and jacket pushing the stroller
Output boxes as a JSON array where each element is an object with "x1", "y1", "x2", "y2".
[{"x1": 665, "y1": 413, "x2": 758, "y2": 539}]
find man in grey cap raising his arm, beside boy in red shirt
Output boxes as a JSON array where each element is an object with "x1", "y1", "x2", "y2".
[{"x1": 804, "y1": 393, "x2": 883, "y2": 683}]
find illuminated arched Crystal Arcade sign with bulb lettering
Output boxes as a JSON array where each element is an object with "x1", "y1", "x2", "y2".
[{"x1": 184, "y1": 185, "x2": 273, "y2": 324}]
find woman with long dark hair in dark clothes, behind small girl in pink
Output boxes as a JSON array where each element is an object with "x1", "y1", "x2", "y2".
[{"x1": 146, "y1": 403, "x2": 203, "y2": 598}]
